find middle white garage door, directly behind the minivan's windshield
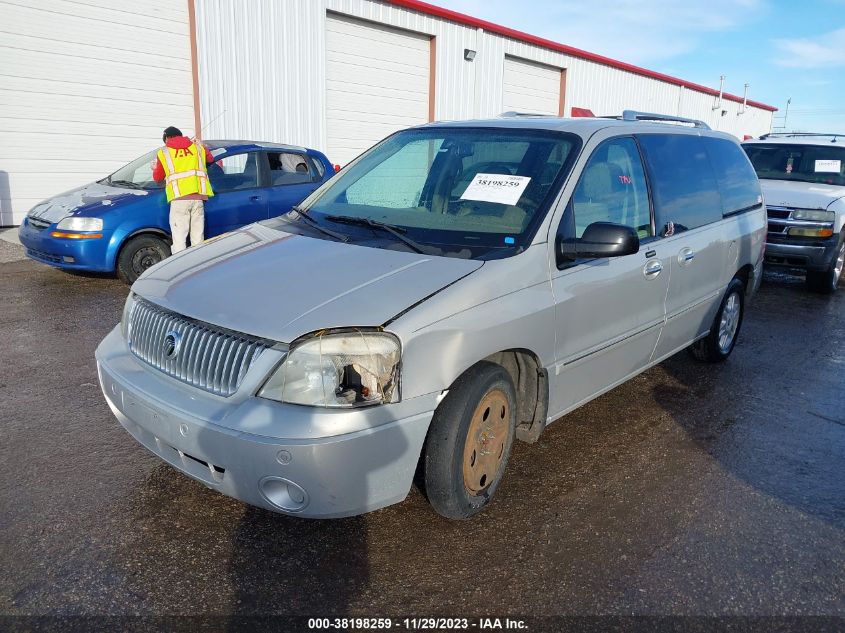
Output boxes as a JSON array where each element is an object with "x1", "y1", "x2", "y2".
[{"x1": 326, "y1": 14, "x2": 431, "y2": 165}]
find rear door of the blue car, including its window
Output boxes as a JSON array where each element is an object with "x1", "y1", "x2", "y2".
[{"x1": 266, "y1": 151, "x2": 325, "y2": 217}]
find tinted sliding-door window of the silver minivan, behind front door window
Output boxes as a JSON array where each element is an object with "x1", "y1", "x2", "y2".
[{"x1": 638, "y1": 134, "x2": 722, "y2": 235}]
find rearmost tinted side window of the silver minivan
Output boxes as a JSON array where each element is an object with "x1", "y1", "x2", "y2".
[{"x1": 702, "y1": 136, "x2": 763, "y2": 217}]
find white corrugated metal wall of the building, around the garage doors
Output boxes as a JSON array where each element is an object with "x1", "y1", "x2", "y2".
[{"x1": 197, "y1": 0, "x2": 772, "y2": 158}]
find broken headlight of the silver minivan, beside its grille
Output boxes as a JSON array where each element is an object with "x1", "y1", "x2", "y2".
[{"x1": 258, "y1": 330, "x2": 401, "y2": 407}]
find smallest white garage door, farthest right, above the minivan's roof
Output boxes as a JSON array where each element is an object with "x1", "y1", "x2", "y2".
[{"x1": 502, "y1": 57, "x2": 560, "y2": 114}]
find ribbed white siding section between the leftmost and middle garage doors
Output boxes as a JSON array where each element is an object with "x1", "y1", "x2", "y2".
[{"x1": 196, "y1": 0, "x2": 326, "y2": 147}]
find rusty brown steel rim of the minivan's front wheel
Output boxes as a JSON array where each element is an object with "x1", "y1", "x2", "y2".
[{"x1": 463, "y1": 389, "x2": 510, "y2": 495}]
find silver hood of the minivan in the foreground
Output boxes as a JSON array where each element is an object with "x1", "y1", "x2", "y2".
[{"x1": 132, "y1": 224, "x2": 483, "y2": 343}]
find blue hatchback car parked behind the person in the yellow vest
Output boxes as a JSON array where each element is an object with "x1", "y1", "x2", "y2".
[{"x1": 19, "y1": 141, "x2": 334, "y2": 283}]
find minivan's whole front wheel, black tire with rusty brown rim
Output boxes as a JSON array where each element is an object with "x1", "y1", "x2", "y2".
[{"x1": 423, "y1": 361, "x2": 516, "y2": 519}]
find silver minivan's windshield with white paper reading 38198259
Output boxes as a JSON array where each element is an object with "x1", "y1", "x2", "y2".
[{"x1": 294, "y1": 127, "x2": 580, "y2": 259}]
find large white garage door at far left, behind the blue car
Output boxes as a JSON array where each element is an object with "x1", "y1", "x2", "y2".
[{"x1": 0, "y1": 0, "x2": 194, "y2": 226}]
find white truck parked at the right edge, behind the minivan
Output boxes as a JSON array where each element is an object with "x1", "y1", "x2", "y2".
[{"x1": 743, "y1": 132, "x2": 845, "y2": 293}]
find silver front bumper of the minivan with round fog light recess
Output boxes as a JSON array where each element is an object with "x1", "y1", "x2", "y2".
[{"x1": 96, "y1": 328, "x2": 437, "y2": 518}]
